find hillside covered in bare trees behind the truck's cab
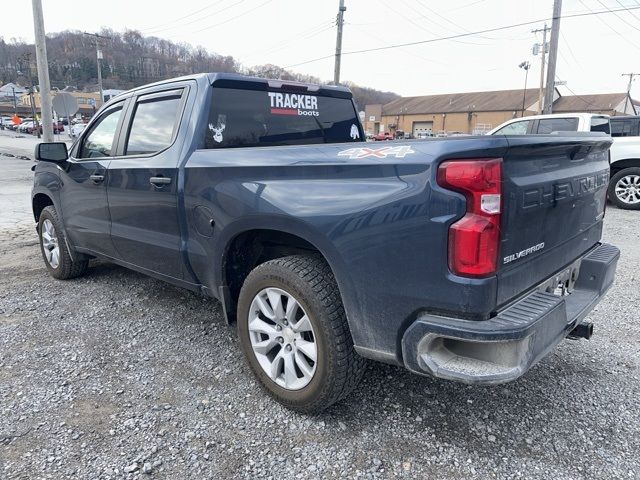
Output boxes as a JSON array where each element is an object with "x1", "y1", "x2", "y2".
[{"x1": 0, "y1": 30, "x2": 399, "y2": 108}]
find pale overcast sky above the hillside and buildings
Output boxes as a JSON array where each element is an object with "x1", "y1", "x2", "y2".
[{"x1": 5, "y1": 0, "x2": 640, "y2": 99}]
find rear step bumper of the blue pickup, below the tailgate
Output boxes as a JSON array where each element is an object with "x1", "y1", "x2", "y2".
[{"x1": 402, "y1": 244, "x2": 620, "y2": 384}]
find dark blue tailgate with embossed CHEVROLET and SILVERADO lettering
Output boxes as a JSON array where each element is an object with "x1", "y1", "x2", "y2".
[{"x1": 497, "y1": 133, "x2": 611, "y2": 305}]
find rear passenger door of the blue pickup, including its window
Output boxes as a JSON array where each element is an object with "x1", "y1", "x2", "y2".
[{"x1": 107, "y1": 87, "x2": 186, "y2": 279}]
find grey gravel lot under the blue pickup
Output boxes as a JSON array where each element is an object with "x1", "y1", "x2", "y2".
[{"x1": 0, "y1": 144, "x2": 640, "y2": 479}]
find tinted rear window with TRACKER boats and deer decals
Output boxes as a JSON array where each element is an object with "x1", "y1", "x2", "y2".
[{"x1": 205, "y1": 87, "x2": 362, "y2": 148}]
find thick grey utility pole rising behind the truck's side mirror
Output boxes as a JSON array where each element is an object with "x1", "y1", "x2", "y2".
[{"x1": 31, "y1": 0, "x2": 53, "y2": 142}]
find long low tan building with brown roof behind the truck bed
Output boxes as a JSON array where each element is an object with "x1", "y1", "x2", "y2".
[{"x1": 364, "y1": 88, "x2": 637, "y2": 137}]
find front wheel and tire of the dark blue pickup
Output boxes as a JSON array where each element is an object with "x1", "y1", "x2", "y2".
[{"x1": 38, "y1": 206, "x2": 89, "y2": 280}]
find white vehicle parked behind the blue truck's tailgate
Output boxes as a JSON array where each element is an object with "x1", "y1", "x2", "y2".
[{"x1": 489, "y1": 113, "x2": 640, "y2": 210}]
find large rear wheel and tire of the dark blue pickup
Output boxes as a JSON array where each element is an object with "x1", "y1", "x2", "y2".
[{"x1": 238, "y1": 255, "x2": 366, "y2": 413}]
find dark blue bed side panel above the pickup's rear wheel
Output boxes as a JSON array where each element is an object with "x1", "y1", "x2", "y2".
[{"x1": 184, "y1": 137, "x2": 506, "y2": 360}]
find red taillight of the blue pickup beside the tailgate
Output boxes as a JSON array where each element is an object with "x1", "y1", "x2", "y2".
[{"x1": 438, "y1": 158, "x2": 502, "y2": 277}]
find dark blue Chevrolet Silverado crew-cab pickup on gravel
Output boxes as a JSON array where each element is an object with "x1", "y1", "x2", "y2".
[{"x1": 32, "y1": 74, "x2": 619, "y2": 412}]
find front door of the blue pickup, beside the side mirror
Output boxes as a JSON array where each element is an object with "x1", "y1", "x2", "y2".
[{"x1": 60, "y1": 102, "x2": 124, "y2": 256}]
